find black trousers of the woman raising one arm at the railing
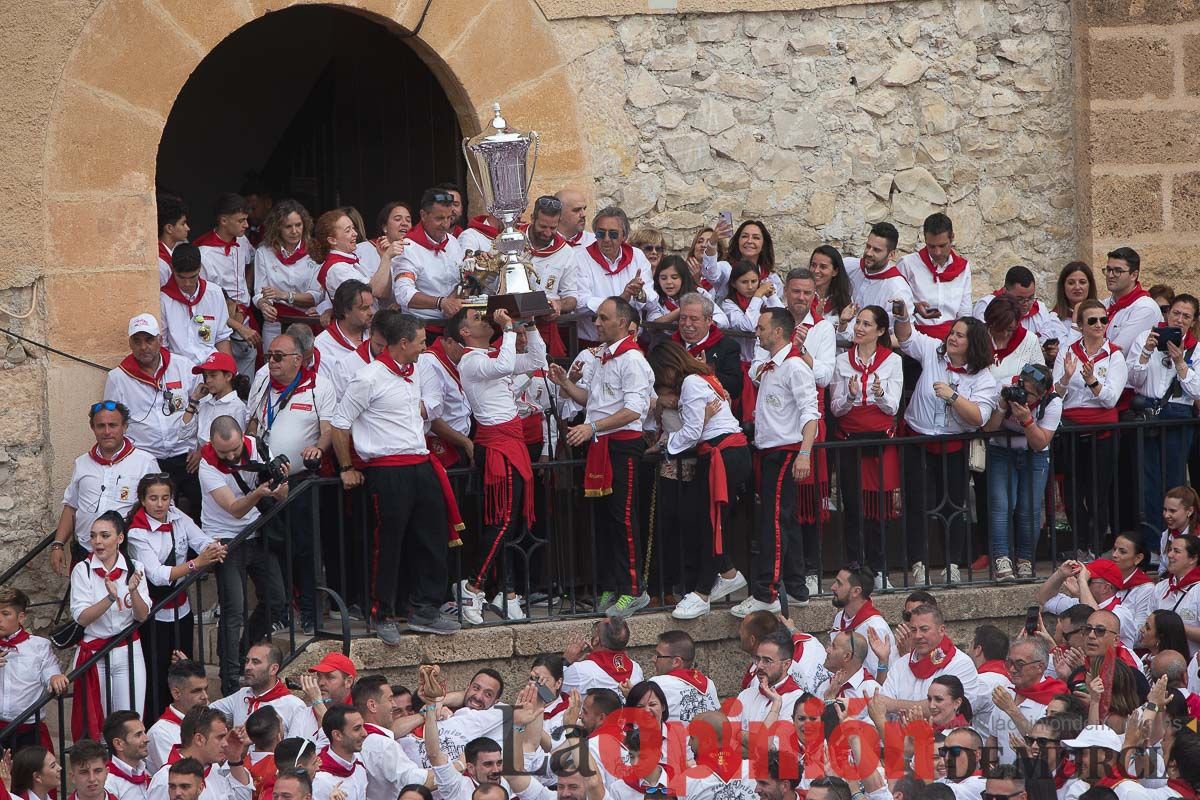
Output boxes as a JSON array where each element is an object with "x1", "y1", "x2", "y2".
[{"x1": 904, "y1": 443, "x2": 971, "y2": 566}]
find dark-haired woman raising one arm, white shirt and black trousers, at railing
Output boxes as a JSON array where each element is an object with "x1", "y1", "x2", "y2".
[{"x1": 895, "y1": 301, "x2": 1000, "y2": 584}]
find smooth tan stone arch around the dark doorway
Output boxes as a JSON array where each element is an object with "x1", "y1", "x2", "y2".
[{"x1": 43, "y1": 0, "x2": 590, "y2": 476}]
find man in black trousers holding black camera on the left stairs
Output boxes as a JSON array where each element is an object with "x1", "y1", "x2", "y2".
[{"x1": 200, "y1": 416, "x2": 288, "y2": 694}]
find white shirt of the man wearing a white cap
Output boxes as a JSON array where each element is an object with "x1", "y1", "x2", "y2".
[{"x1": 104, "y1": 350, "x2": 199, "y2": 458}]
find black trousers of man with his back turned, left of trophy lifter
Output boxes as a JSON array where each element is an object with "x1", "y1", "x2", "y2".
[{"x1": 366, "y1": 463, "x2": 450, "y2": 619}]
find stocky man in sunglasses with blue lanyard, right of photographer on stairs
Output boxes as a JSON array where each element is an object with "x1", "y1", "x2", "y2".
[{"x1": 246, "y1": 333, "x2": 337, "y2": 633}]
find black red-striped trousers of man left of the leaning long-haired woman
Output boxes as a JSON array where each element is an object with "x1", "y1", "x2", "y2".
[{"x1": 593, "y1": 438, "x2": 646, "y2": 596}]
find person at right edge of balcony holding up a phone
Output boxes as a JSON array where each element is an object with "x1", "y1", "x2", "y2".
[{"x1": 1128, "y1": 294, "x2": 1200, "y2": 561}]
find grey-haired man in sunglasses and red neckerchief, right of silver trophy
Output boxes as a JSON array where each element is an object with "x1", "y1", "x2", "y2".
[{"x1": 577, "y1": 205, "x2": 658, "y2": 347}]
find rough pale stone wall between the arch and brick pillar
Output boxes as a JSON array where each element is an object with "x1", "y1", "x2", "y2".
[{"x1": 554, "y1": 0, "x2": 1076, "y2": 290}]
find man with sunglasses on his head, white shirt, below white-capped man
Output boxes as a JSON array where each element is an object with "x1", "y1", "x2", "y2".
[{"x1": 50, "y1": 401, "x2": 161, "y2": 577}]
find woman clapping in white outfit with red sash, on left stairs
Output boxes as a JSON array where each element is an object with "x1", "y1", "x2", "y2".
[{"x1": 71, "y1": 511, "x2": 150, "y2": 739}]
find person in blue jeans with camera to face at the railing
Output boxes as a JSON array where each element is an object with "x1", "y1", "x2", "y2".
[{"x1": 983, "y1": 362, "x2": 1062, "y2": 579}]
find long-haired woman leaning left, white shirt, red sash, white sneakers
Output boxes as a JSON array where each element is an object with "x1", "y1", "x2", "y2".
[{"x1": 650, "y1": 342, "x2": 750, "y2": 619}]
